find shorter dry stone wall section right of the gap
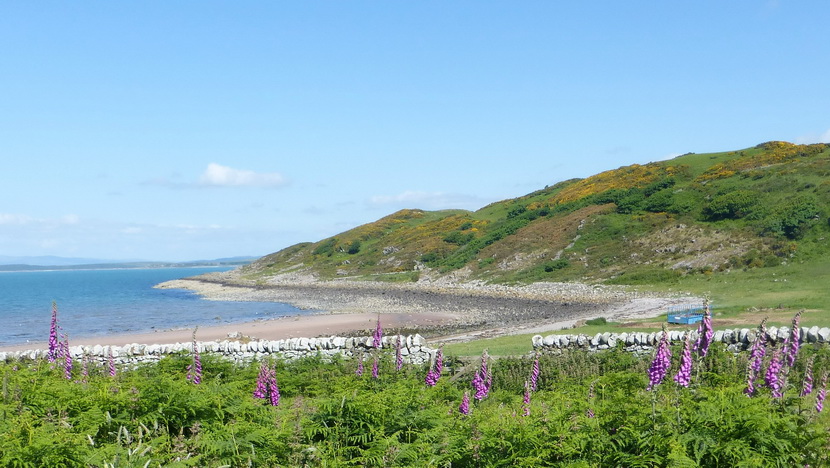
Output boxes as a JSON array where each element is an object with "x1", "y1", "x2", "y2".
[{"x1": 532, "y1": 327, "x2": 830, "y2": 352}]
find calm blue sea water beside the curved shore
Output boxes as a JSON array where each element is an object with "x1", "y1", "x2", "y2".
[{"x1": 0, "y1": 267, "x2": 303, "y2": 346}]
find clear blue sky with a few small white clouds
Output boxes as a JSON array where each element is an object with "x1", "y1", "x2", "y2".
[{"x1": 0, "y1": 0, "x2": 830, "y2": 260}]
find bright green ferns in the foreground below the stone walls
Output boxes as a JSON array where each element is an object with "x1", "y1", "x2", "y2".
[{"x1": 0, "y1": 341, "x2": 830, "y2": 467}]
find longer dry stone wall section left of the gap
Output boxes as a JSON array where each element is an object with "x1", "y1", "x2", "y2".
[{"x1": 0, "y1": 334, "x2": 435, "y2": 365}]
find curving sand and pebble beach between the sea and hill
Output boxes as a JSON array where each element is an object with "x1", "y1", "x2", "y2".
[{"x1": 0, "y1": 274, "x2": 694, "y2": 351}]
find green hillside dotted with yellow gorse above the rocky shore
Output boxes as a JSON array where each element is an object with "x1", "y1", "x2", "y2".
[{"x1": 239, "y1": 142, "x2": 830, "y2": 310}]
